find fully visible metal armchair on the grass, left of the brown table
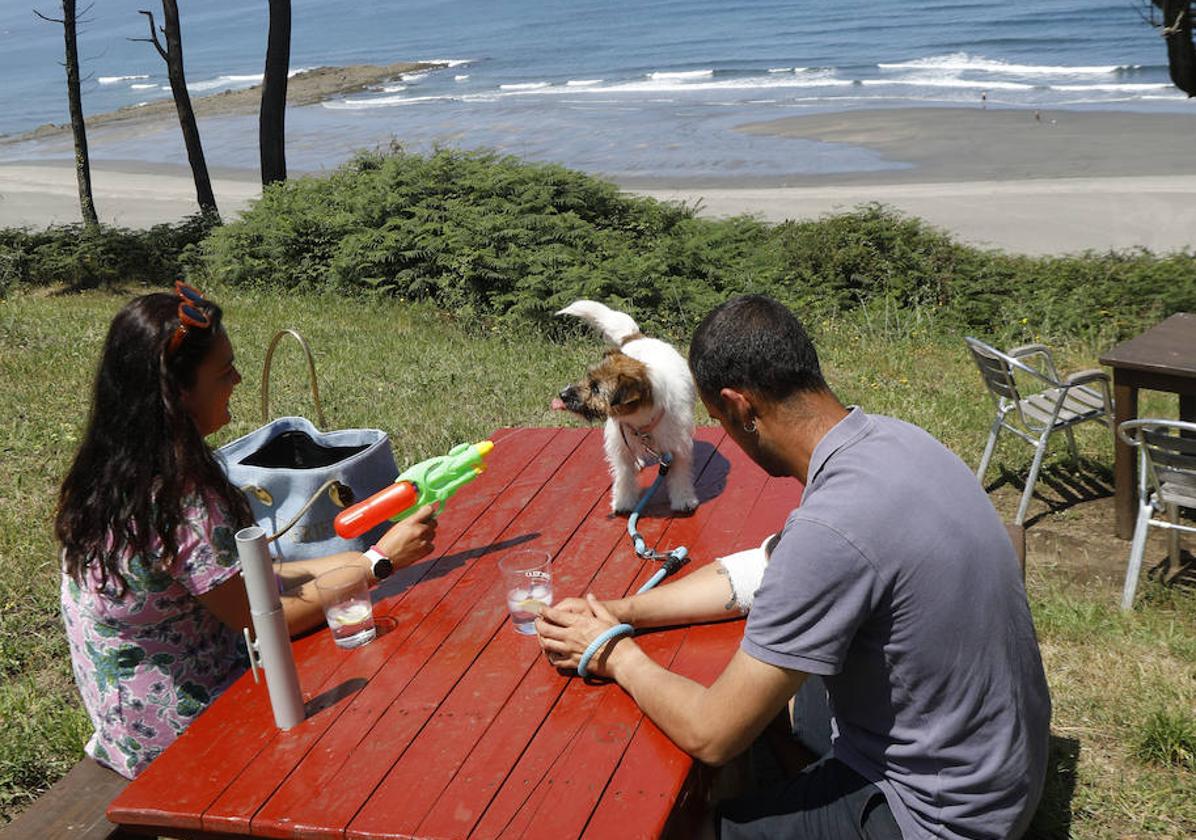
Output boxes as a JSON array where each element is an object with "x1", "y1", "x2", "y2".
[{"x1": 964, "y1": 337, "x2": 1113, "y2": 525}]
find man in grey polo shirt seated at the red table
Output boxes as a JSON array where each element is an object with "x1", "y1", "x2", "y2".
[{"x1": 536, "y1": 296, "x2": 1050, "y2": 839}]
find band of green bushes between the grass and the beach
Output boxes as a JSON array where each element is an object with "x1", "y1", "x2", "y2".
[{"x1": 0, "y1": 151, "x2": 1196, "y2": 342}]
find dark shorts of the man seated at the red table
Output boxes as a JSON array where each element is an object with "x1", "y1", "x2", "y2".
[{"x1": 714, "y1": 756, "x2": 901, "y2": 840}]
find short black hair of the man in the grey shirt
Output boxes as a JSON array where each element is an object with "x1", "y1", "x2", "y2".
[{"x1": 689, "y1": 294, "x2": 826, "y2": 403}]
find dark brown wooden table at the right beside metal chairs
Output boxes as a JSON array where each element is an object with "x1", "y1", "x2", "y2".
[{"x1": 1100, "y1": 312, "x2": 1196, "y2": 540}]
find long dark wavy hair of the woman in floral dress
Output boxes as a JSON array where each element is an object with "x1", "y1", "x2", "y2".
[{"x1": 54, "y1": 294, "x2": 251, "y2": 594}]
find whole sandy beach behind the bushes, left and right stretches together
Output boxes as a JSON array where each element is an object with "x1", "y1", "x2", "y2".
[{"x1": 0, "y1": 109, "x2": 1196, "y2": 254}]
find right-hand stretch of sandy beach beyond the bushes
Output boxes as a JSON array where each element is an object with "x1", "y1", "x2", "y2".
[{"x1": 641, "y1": 108, "x2": 1196, "y2": 254}]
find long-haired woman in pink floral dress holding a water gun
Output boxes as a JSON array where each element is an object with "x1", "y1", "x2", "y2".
[{"x1": 55, "y1": 282, "x2": 435, "y2": 778}]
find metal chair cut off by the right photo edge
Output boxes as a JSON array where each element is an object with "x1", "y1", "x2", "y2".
[{"x1": 1117, "y1": 420, "x2": 1196, "y2": 609}]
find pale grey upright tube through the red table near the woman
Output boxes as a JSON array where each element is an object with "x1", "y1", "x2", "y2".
[{"x1": 237, "y1": 525, "x2": 305, "y2": 729}]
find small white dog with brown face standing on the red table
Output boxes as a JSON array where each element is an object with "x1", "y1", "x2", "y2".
[{"x1": 553, "y1": 300, "x2": 697, "y2": 513}]
